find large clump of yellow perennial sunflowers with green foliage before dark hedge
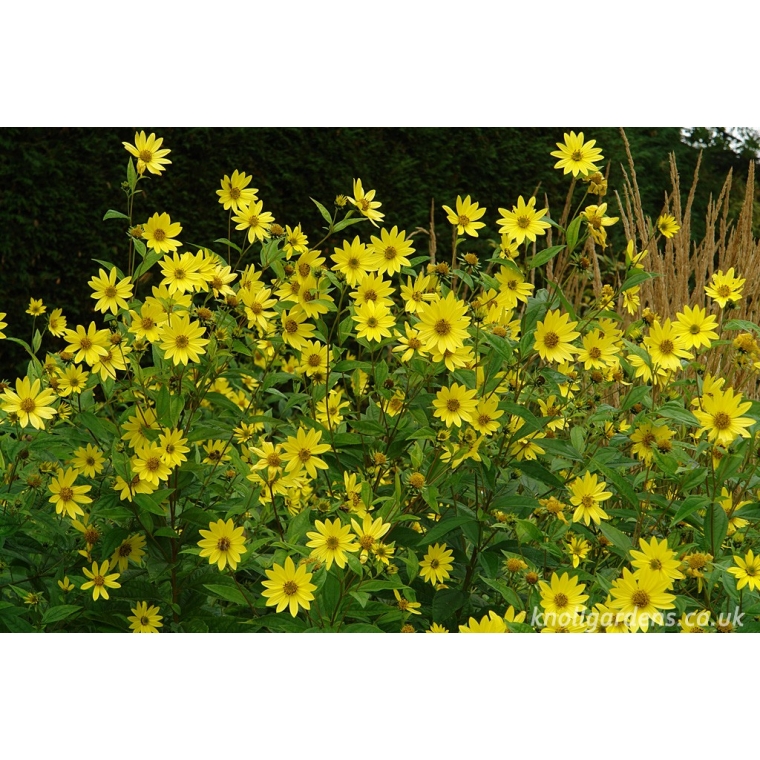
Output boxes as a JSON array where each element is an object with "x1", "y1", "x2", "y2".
[{"x1": 0, "y1": 132, "x2": 760, "y2": 633}]
